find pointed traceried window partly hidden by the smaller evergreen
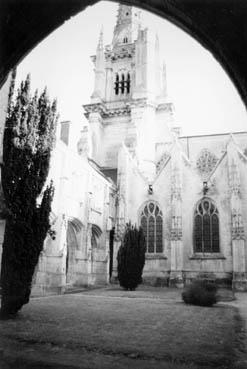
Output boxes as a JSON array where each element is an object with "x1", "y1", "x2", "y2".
[{"x1": 140, "y1": 201, "x2": 163, "y2": 254}]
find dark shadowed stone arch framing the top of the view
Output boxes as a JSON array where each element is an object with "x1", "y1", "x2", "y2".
[{"x1": 0, "y1": 0, "x2": 247, "y2": 111}]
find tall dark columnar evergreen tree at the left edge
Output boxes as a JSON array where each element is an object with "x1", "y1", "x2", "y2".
[{"x1": 1, "y1": 72, "x2": 57, "y2": 317}]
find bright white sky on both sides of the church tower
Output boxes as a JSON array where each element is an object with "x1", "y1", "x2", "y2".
[{"x1": 17, "y1": 1, "x2": 247, "y2": 135}]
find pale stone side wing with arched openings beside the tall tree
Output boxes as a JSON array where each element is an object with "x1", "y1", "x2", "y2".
[{"x1": 32, "y1": 131, "x2": 114, "y2": 295}]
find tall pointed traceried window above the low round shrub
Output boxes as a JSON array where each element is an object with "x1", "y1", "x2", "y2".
[{"x1": 194, "y1": 197, "x2": 220, "y2": 253}]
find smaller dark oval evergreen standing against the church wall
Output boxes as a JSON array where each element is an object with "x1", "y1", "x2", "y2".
[{"x1": 117, "y1": 224, "x2": 146, "y2": 290}]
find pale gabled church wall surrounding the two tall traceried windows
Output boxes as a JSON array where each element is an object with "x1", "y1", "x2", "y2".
[{"x1": 119, "y1": 133, "x2": 247, "y2": 289}]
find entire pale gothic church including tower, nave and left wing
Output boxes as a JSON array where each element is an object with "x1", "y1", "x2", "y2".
[{"x1": 0, "y1": 5, "x2": 247, "y2": 294}]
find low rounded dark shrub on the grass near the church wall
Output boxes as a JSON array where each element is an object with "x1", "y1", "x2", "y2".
[{"x1": 182, "y1": 279, "x2": 217, "y2": 306}]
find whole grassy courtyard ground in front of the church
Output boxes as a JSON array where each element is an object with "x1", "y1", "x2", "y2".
[{"x1": 0, "y1": 286, "x2": 247, "y2": 369}]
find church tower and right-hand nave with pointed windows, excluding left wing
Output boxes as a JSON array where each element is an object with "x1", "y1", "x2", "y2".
[{"x1": 81, "y1": 5, "x2": 247, "y2": 289}]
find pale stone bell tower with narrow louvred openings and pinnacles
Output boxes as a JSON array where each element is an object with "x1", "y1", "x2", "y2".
[{"x1": 83, "y1": 4, "x2": 176, "y2": 179}]
